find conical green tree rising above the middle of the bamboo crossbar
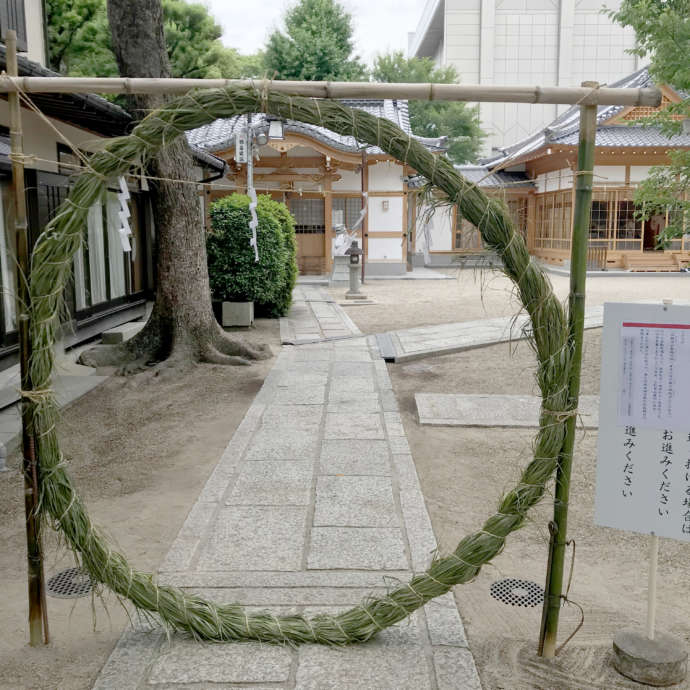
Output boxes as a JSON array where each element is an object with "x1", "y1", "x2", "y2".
[{"x1": 264, "y1": 0, "x2": 366, "y2": 81}]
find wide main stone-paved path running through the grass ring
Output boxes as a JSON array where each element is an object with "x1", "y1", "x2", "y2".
[{"x1": 95, "y1": 338, "x2": 481, "y2": 690}]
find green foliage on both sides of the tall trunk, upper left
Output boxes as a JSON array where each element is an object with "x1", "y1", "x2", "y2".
[{"x1": 46, "y1": 0, "x2": 264, "y2": 79}]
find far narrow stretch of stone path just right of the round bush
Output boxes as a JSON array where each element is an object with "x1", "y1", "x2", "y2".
[{"x1": 280, "y1": 283, "x2": 361, "y2": 345}]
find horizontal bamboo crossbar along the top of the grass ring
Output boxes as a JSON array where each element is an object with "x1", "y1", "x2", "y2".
[{"x1": 0, "y1": 75, "x2": 661, "y2": 107}]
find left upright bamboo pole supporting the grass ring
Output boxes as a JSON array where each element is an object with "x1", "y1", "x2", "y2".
[{"x1": 5, "y1": 30, "x2": 49, "y2": 647}]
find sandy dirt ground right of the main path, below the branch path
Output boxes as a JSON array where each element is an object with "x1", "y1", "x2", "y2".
[{"x1": 388, "y1": 330, "x2": 690, "y2": 690}]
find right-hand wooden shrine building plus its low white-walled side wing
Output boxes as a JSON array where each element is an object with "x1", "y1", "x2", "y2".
[{"x1": 417, "y1": 69, "x2": 690, "y2": 271}]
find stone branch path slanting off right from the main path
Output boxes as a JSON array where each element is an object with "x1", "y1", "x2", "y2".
[{"x1": 376, "y1": 307, "x2": 604, "y2": 362}]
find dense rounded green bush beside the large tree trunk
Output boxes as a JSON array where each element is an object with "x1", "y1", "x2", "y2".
[{"x1": 206, "y1": 194, "x2": 297, "y2": 316}]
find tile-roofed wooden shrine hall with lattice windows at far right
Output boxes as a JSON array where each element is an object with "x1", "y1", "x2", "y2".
[{"x1": 483, "y1": 68, "x2": 690, "y2": 271}]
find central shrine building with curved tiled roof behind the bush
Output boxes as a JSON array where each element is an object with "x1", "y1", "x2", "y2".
[{"x1": 188, "y1": 99, "x2": 445, "y2": 275}]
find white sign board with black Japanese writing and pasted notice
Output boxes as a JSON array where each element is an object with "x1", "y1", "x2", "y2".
[{"x1": 594, "y1": 303, "x2": 690, "y2": 541}]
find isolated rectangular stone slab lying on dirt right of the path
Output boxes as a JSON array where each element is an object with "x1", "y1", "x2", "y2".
[{"x1": 414, "y1": 393, "x2": 599, "y2": 429}]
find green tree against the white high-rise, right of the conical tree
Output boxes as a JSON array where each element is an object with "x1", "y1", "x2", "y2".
[{"x1": 372, "y1": 51, "x2": 484, "y2": 163}]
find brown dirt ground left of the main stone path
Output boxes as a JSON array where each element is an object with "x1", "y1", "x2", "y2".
[{"x1": 0, "y1": 320, "x2": 279, "y2": 690}]
